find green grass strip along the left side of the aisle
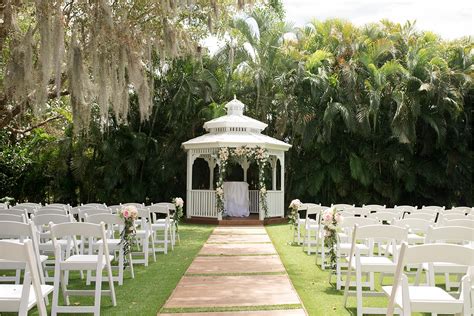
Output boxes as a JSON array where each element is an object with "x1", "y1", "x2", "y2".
[{"x1": 23, "y1": 224, "x2": 214, "y2": 316}]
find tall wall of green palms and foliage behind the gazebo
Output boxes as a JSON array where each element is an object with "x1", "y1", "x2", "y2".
[{"x1": 0, "y1": 1, "x2": 474, "y2": 210}]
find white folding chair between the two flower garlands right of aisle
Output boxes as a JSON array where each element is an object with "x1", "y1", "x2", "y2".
[{"x1": 303, "y1": 203, "x2": 325, "y2": 258}]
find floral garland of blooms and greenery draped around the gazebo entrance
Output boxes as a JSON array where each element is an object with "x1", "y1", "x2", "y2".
[{"x1": 216, "y1": 146, "x2": 269, "y2": 217}]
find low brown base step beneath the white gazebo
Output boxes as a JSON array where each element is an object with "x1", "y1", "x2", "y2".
[{"x1": 186, "y1": 214, "x2": 288, "y2": 226}]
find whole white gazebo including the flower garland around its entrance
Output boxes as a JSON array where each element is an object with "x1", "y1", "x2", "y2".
[{"x1": 183, "y1": 98, "x2": 291, "y2": 220}]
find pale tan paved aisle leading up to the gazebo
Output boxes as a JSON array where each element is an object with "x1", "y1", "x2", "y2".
[{"x1": 160, "y1": 226, "x2": 306, "y2": 316}]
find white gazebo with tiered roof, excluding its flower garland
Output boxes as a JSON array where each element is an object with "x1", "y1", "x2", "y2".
[{"x1": 183, "y1": 98, "x2": 291, "y2": 220}]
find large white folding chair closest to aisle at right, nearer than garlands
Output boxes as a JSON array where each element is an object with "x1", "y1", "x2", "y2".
[{"x1": 344, "y1": 224, "x2": 408, "y2": 316}]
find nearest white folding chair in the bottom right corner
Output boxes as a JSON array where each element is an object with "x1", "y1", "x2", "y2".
[{"x1": 382, "y1": 243, "x2": 474, "y2": 316}]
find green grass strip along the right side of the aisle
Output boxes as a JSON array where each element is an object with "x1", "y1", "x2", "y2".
[{"x1": 266, "y1": 225, "x2": 443, "y2": 315}]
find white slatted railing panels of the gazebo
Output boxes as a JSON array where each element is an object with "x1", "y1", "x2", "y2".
[{"x1": 187, "y1": 190, "x2": 284, "y2": 218}]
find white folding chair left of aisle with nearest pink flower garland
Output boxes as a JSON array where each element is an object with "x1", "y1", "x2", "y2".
[{"x1": 85, "y1": 213, "x2": 135, "y2": 285}]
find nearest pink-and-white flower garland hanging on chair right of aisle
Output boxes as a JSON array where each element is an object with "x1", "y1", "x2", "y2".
[{"x1": 321, "y1": 207, "x2": 343, "y2": 270}]
